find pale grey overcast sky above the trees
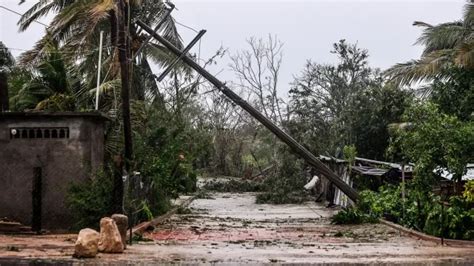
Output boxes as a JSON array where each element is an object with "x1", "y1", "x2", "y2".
[{"x1": 0, "y1": 0, "x2": 465, "y2": 94}]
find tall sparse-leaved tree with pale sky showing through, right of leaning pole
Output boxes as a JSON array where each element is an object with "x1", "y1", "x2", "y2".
[{"x1": 290, "y1": 40, "x2": 381, "y2": 154}]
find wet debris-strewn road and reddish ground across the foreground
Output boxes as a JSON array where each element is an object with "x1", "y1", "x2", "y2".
[{"x1": 0, "y1": 193, "x2": 474, "y2": 265}]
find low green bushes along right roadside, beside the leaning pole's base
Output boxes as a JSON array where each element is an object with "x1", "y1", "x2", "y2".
[{"x1": 332, "y1": 186, "x2": 474, "y2": 240}]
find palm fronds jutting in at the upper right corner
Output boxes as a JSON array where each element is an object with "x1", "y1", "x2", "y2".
[{"x1": 385, "y1": 0, "x2": 474, "y2": 85}]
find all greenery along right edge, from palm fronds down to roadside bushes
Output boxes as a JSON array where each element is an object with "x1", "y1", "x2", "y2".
[{"x1": 333, "y1": 3, "x2": 474, "y2": 240}]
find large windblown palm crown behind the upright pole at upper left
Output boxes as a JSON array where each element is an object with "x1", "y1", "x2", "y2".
[{"x1": 18, "y1": 0, "x2": 182, "y2": 105}]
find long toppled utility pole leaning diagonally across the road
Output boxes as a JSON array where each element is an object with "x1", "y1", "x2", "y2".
[{"x1": 136, "y1": 20, "x2": 359, "y2": 202}]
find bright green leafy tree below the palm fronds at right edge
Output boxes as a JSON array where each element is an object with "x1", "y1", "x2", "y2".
[{"x1": 393, "y1": 103, "x2": 474, "y2": 189}]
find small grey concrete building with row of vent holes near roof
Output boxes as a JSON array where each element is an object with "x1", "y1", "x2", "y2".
[{"x1": 0, "y1": 112, "x2": 107, "y2": 229}]
